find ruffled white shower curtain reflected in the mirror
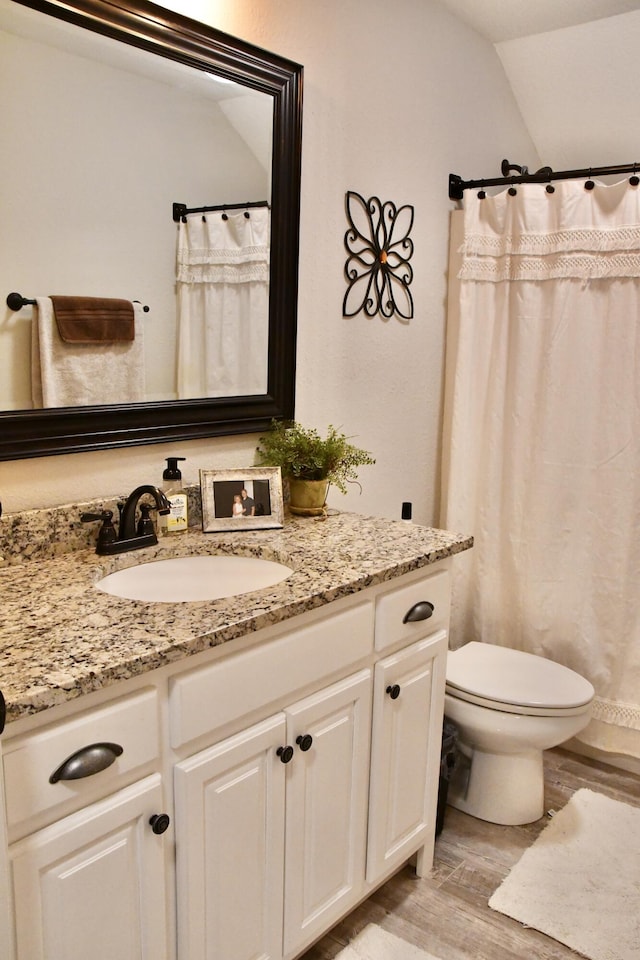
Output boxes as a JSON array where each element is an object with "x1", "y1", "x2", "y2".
[{"x1": 176, "y1": 207, "x2": 270, "y2": 399}]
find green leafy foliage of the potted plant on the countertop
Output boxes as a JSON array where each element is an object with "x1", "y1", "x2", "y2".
[{"x1": 256, "y1": 420, "x2": 376, "y2": 493}]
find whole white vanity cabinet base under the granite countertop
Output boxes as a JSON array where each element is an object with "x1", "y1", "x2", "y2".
[{"x1": 0, "y1": 562, "x2": 449, "y2": 960}]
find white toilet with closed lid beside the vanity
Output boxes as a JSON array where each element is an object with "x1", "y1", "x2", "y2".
[{"x1": 444, "y1": 640, "x2": 595, "y2": 824}]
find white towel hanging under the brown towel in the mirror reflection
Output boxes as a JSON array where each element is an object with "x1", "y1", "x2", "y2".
[{"x1": 31, "y1": 297, "x2": 146, "y2": 408}]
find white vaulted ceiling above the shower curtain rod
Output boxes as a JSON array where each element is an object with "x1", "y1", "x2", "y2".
[{"x1": 439, "y1": 0, "x2": 640, "y2": 170}]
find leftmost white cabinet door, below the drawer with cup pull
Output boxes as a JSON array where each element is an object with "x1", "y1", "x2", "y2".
[{"x1": 10, "y1": 775, "x2": 168, "y2": 960}]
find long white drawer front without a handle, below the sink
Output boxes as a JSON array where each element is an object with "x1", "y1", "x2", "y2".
[{"x1": 170, "y1": 602, "x2": 374, "y2": 747}]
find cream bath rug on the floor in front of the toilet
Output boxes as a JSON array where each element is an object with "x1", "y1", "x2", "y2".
[{"x1": 489, "y1": 790, "x2": 640, "y2": 960}]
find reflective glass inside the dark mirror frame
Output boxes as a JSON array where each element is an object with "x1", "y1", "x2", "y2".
[{"x1": 0, "y1": 0, "x2": 273, "y2": 411}]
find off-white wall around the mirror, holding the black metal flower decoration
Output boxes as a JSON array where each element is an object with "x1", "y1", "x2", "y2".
[{"x1": 0, "y1": 0, "x2": 534, "y2": 523}]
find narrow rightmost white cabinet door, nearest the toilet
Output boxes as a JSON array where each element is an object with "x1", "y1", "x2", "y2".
[{"x1": 367, "y1": 630, "x2": 447, "y2": 883}]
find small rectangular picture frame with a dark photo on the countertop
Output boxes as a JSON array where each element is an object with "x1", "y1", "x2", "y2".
[{"x1": 200, "y1": 467, "x2": 284, "y2": 533}]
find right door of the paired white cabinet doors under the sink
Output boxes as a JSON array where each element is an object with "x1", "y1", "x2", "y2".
[{"x1": 284, "y1": 670, "x2": 371, "y2": 956}]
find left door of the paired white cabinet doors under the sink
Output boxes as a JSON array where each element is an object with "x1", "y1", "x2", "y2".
[{"x1": 175, "y1": 713, "x2": 285, "y2": 960}]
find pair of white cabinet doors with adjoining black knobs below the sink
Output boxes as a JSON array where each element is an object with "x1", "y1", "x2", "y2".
[{"x1": 175, "y1": 669, "x2": 371, "y2": 960}]
